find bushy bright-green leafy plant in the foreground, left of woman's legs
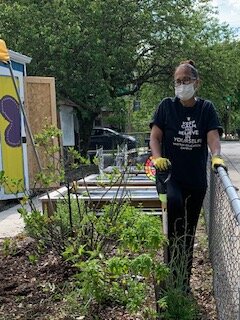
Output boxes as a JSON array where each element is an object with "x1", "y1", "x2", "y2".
[{"x1": 60, "y1": 203, "x2": 167, "y2": 312}]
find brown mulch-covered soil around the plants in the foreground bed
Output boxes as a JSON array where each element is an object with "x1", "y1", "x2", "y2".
[{"x1": 0, "y1": 220, "x2": 217, "y2": 320}]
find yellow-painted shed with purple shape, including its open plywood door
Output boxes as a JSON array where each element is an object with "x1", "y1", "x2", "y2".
[{"x1": 0, "y1": 50, "x2": 59, "y2": 200}]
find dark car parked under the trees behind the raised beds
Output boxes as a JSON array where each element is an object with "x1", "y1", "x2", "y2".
[{"x1": 89, "y1": 127, "x2": 137, "y2": 150}]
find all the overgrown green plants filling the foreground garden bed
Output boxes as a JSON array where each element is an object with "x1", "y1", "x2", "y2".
[{"x1": 0, "y1": 127, "x2": 203, "y2": 320}]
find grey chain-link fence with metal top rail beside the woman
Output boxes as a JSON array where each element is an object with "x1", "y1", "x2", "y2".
[{"x1": 204, "y1": 166, "x2": 240, "y2": 320}]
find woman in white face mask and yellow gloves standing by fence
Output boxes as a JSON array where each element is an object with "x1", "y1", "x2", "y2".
[{"x1": 150, "y1": 60, "x2": 225, "y2": 291}]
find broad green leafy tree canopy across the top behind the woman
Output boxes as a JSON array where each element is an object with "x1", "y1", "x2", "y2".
[{"x1": 0, "y1": 0, "x2": 239, "y2": 146}]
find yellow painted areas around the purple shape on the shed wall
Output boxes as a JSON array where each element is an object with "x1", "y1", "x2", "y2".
[{"x1": 0, "y1": 76, "x2": 24, "y2": 194}]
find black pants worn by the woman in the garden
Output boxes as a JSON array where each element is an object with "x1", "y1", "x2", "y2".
[{"x1": 167, "y1": 179, "x2": 206, "y2": 288}]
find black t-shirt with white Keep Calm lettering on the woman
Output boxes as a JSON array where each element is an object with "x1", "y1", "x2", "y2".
[{"x1": 150, "y1": 98, "x2": 222, "y2": 189}]
